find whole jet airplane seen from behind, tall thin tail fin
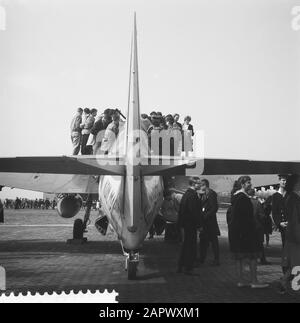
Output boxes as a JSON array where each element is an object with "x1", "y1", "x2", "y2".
[{"x1": 0, "y1": 14, "x2": 300, "y2": 279}]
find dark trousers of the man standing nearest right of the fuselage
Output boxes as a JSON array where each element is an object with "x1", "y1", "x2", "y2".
[{"x1": 178, "y1": 226, "x2": 197, "y2": 271}]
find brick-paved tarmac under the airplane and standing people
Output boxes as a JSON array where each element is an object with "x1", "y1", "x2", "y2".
[{"x1": 0, "y1": 210, "x2": 300, "y2": 303}]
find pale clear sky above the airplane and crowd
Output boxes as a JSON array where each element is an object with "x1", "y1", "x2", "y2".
[{"x1": 0, "y1": 0, "x2": 300, "y2": 198}]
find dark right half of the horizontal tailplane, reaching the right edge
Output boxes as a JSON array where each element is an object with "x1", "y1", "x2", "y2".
[{"x1": 141, "y1": 157, "x2": 300, "y2": 176}]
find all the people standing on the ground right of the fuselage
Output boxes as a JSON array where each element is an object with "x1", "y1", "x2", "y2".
[{"x1": 157, "y1": 175, "x2": 300, "y2": 293}]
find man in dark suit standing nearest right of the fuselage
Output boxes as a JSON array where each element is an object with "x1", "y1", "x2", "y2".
[{"x1": 177, "y1": 177, "x2": 202, "y2": 275}]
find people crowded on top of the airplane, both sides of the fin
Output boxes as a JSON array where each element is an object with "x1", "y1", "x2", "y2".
[{"x1": 70, "y1": 108, "x2": 195, "y2": 155}]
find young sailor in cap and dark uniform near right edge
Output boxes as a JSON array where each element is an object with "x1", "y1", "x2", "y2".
[{"x1": 272, "y1": 175, "x2": 288, "y2": 247}]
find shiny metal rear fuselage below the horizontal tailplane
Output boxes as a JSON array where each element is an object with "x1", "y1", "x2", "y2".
[{"x1": 99, "y1": 176, "x2": 164, "y2": 250}]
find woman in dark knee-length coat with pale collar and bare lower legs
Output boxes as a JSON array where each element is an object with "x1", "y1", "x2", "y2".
[{"x1": 229, "y1": 176, "x2": 268, "y2": 288}]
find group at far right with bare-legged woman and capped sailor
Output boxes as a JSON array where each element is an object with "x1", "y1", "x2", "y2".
[{"x1": 228, "y1": 175, "x2": 300, "y2": 293}]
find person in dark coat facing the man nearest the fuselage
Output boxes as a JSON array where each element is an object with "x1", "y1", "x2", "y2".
[{"x1": 199, "y1": 179, "x2": 221, "y2": 266}]
